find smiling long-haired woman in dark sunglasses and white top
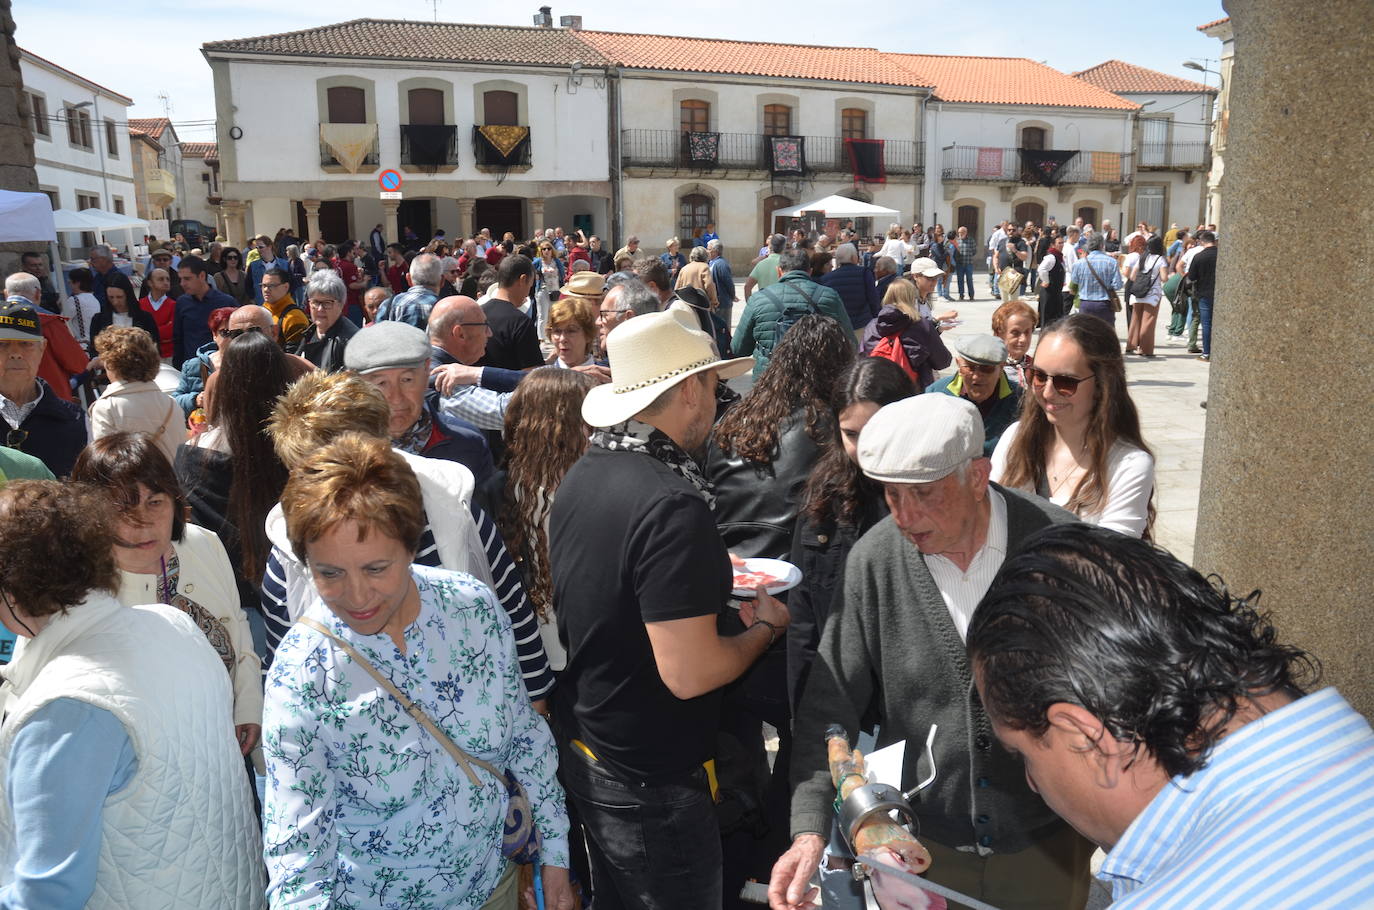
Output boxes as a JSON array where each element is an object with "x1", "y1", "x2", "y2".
[{"x1": 992, "y1": 313, "x2": 1154, "y2": 537}]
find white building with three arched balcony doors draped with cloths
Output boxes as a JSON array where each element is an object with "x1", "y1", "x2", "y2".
[{"x1": 202, "y1": 19, "x2": 611, "y2": 242}]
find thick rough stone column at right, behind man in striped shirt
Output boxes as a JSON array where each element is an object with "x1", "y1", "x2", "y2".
[{"x1": 1194, "y1": 0, "x2": 1374, "y2": 715}]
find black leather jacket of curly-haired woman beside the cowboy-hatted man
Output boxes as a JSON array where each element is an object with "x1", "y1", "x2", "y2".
[{"x1": 705, "y1": 410, "x2": 826, "y2": 559}]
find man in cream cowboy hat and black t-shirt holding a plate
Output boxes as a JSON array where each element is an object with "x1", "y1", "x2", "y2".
[{"x1": 548, "y1": 304, "x2": 787, "y2": 910}]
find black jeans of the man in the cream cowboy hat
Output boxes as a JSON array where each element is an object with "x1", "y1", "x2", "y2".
[{"x1": 559, "y1": 745, "x2": 723, "y2": 910}]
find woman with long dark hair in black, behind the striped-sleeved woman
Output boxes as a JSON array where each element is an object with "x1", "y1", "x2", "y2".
[{"x1": 176, "y1": 331, "x2": 293, "y2": 621}]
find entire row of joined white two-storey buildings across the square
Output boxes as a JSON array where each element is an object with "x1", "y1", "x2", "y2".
[{"x1": 202, "y1": 14, "x2": 1210, "y2": 264}]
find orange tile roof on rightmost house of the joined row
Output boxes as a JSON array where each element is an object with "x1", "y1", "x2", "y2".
[{"x1": 883, "y1": 54, "x2": 1138, "y2": 110}]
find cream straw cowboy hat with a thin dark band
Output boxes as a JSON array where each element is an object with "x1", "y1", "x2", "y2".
[{"x1": 583, "y1": 304, "x2": 754, "y2": 426}]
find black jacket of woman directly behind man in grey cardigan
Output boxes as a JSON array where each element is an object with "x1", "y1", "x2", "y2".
[{"x1": 787, "y1": 491, "x2": 888, "y2": 711}]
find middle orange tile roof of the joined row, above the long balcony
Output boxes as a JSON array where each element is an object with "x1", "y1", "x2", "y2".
[{"x1": 576, "y1": 32, "x2": 930, "y2": 87}]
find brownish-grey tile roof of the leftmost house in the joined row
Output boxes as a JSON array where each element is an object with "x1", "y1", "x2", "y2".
[{"x1": 201, "y1": 19, "x2": 606, "y2": 66}]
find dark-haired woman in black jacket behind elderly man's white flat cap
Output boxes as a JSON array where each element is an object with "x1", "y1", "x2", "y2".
[{"x1": 787, "y1": 357, "x2": 919, "y2": 707}]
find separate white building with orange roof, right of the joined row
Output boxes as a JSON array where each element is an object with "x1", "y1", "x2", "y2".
[{"x1": 1074, "y1": 60, "x2": 1216, "y2": 235}]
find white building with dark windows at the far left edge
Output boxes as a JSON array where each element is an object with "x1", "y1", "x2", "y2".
[{"x1": 19, "y1": 49, "x2": 135, "y2": 219}]
